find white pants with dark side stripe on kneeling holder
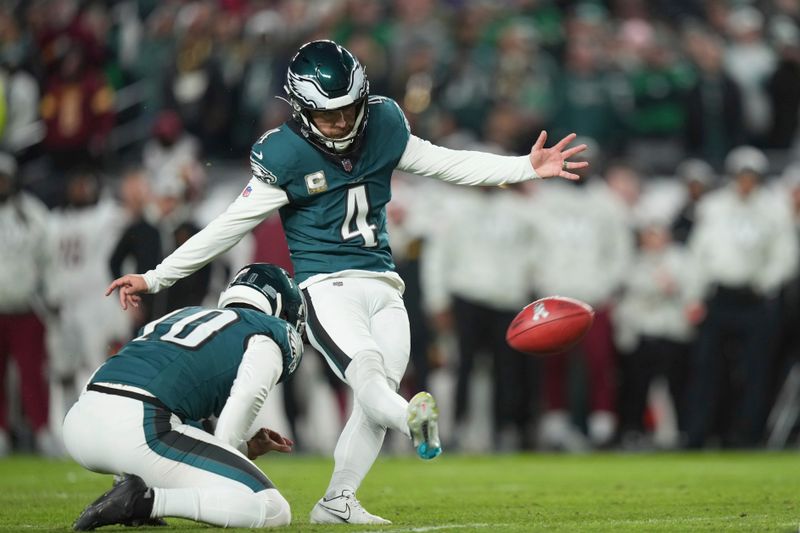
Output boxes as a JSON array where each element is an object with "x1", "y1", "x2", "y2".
[{"x1": 64, "y1": 385, "x2": 291, "y2": 528}]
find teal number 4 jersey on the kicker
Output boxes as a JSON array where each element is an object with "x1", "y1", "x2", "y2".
[{"x1": 250, "y1": 96, "x2": 410, "y2": 282}]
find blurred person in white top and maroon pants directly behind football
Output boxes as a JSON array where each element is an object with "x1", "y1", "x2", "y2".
[{"x1": 530, "y1": 168, "x2": 634, "y2": 451}]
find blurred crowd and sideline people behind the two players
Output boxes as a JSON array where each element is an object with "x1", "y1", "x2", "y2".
[{"x1": 0, "y1": 0, "x2": 800, "y2": 456}]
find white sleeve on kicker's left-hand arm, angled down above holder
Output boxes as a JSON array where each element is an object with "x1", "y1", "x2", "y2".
[{"x1": 144, "y1": 177, "x2": 289, "y2": 293}]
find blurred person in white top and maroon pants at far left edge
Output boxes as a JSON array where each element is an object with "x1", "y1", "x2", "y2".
[{"x1": 0, "y1": 153, "x2": 57, "y2": 457}]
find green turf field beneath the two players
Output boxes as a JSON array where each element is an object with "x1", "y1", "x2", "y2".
[{"x1": 0, "y1": 453, "x2": 800, "y2": 532}]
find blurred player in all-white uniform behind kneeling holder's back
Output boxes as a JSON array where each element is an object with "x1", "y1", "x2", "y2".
[{"x1": 47, "y1": 169, "x2": 130, "y2": 426}]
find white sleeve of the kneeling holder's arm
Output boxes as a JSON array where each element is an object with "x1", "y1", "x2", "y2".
[{"x1": 214, "y1": 335, "x2": 283, "y2": 455}]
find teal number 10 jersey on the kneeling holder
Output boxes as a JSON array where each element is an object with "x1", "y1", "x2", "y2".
[{"x1": 91, "y1": 307, "x2": 303, "y2": 420}]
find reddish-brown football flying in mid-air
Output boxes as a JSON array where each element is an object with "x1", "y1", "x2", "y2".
[{"x1": 506, "y1": 296, "x2": 594, "y2": 355}]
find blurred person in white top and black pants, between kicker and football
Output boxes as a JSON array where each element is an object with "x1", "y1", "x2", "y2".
[{"x1": 422, "y1": 182, "x2": 537, "y2": 451}]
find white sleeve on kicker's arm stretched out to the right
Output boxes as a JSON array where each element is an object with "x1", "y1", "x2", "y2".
[{"x1": 397, "y1": 135, "x2": 540, "y2": 185}]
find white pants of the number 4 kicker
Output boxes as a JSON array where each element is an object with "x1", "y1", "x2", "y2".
[{"x1": 304, "y1": 277, "x2": 411, "y2": 492}]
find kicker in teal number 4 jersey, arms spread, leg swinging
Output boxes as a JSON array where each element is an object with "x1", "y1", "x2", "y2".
[{"x1": 106, "y1": 41, "x2": 587, "y2": 524}]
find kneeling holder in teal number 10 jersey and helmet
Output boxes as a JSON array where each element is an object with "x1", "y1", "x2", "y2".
[{"x1": 64, "y1": 263, "x2": 305, "y2": 531}]
